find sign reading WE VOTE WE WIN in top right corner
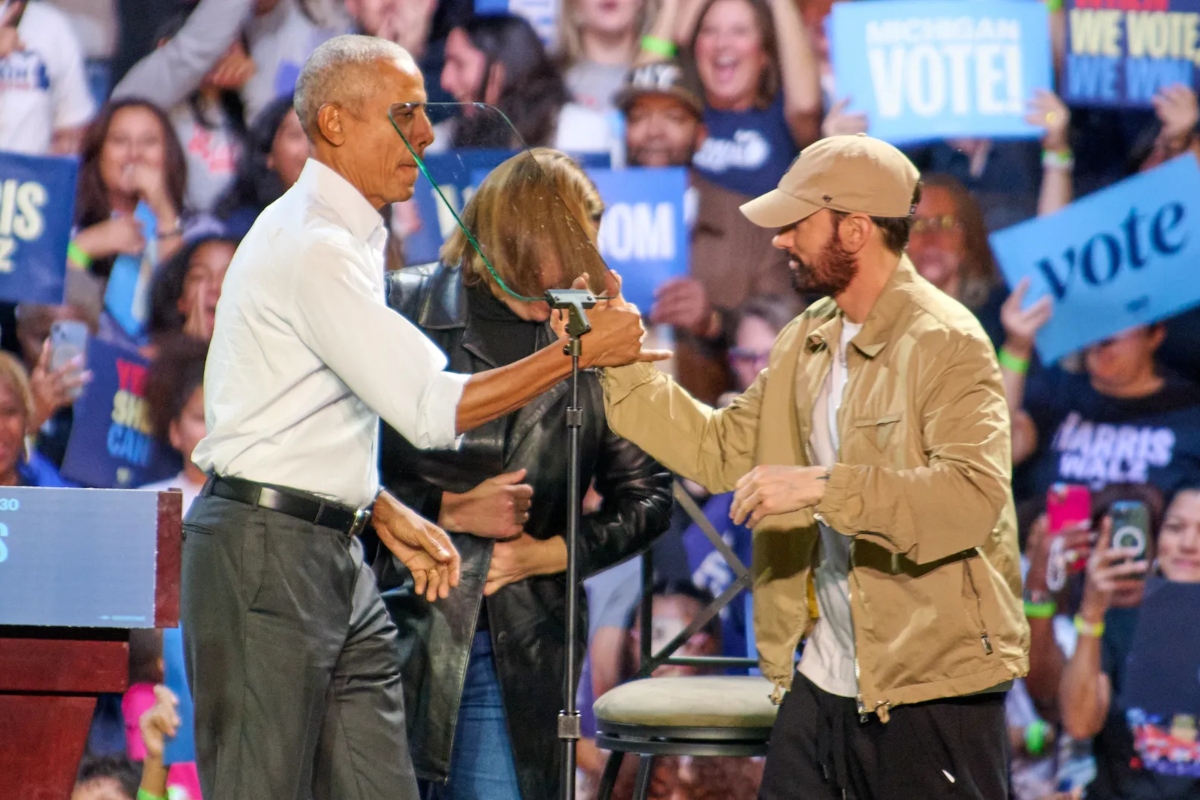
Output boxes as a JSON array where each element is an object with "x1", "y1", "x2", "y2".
[{"x1": 1063, "y1": 0, "x2": 1200, "y2": 107}]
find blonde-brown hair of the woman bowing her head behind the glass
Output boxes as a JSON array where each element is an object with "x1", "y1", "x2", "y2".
[{"x1": 442, "y1": 148, "x2": 605, "y2": 297}]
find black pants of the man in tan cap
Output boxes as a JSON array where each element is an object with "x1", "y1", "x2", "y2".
[{"x1": 758, "y1": 673, "x2": 1009, "y2": 800}]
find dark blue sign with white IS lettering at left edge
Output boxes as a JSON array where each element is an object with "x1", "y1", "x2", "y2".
[{"x1": 0, "y1": 152, "x2": 78, "y2": 306}]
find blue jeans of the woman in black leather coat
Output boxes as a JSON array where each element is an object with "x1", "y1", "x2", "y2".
[{"x1": 433, "y1": 631, "x2": 521, "y2": 800}]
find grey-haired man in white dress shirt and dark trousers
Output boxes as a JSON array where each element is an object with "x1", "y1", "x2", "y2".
[{"x1": 182, "y1": 36, "x2": 661, "y2": 800}]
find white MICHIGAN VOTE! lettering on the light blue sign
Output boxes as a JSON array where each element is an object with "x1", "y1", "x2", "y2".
[{"x1": 866, "y1": 18, "x2": 1026, "y2": 119}]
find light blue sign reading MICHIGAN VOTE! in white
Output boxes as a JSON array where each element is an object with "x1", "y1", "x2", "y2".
[{"x1": 829, "y1": 0, "x2": 1051, "y2": 143}]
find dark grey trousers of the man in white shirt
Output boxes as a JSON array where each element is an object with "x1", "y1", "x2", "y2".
[{"x1": 181, "y1": 497, "x2": 418, "y2": 800}]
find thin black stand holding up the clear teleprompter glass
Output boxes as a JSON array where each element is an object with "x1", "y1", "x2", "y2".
[{"x1": 546, "y1": 289, "x2": 596, "y2": 800}]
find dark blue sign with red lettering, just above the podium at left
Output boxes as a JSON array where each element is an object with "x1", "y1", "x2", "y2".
[{"x1": 62, "y1": 339, "x2": 180, "y2": 489}]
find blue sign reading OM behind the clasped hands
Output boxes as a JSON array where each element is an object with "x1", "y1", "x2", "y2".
[{"x1": 588, "y1": 167, "x2": 689, "y2": 313}]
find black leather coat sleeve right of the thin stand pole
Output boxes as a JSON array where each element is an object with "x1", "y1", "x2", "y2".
[{"x1": 578, "y1": 426, "x2": 673, "y2": 577}]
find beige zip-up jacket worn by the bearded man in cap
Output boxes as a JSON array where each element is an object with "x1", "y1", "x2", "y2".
[{"x1": 604, "y1": 257, "x2": 1030, "y2": 722}]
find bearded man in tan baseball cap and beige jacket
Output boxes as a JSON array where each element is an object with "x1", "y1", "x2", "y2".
[{"x1": 604, "y1": 128, "x2": 1030, "y2": 800}]
